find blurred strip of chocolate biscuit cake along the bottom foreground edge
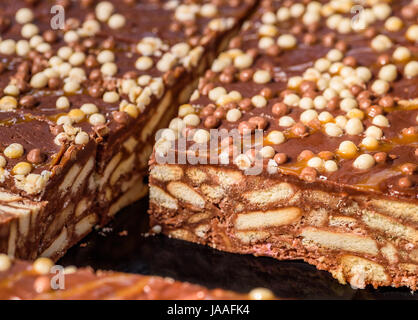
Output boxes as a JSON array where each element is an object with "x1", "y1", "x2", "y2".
[{"x1": 0, "y1": 254, "x2": 275, "y2": 300}]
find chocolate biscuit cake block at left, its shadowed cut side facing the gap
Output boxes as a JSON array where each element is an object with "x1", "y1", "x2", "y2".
[{"x1": 0, "y1": 0, "x2": 255, "y2": 259}]
